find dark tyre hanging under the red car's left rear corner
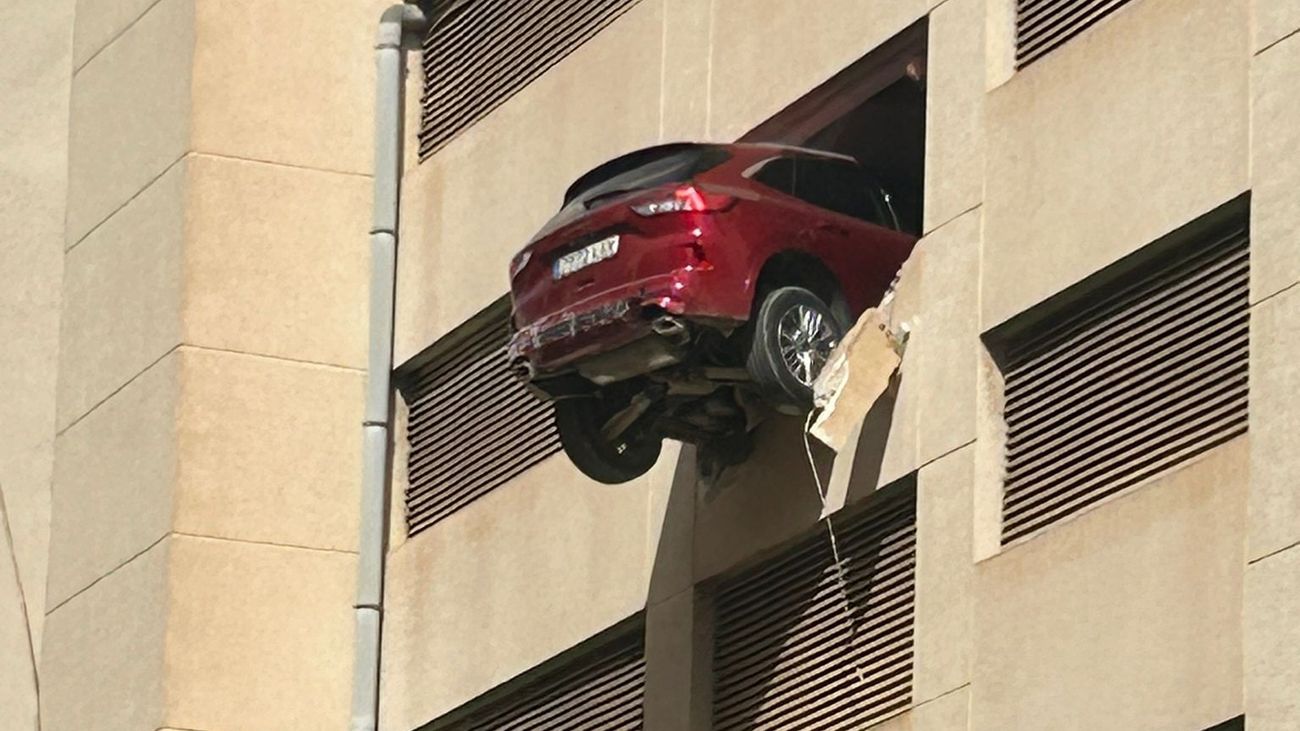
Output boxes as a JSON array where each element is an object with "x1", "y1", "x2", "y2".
[{"x1": 555, "y1": 397, "x2": 663, "y2": 485}]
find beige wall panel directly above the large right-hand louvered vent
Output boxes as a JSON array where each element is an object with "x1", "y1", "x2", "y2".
[{"x1": 982, "y1": 0, "x2": 1249, "y2": 323}]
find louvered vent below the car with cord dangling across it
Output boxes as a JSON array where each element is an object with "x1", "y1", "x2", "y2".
[{"x1": 714, "y1": 485, "x2": 917, "y2": 731}]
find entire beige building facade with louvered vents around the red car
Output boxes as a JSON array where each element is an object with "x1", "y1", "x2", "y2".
[{"x1": 0, "y1": 0, "x2": 1300, "y2": 731}]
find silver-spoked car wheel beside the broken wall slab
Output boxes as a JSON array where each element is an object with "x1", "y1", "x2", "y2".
[{"x1": 746, "y1": 286, "x2": 846, "y2": 411}]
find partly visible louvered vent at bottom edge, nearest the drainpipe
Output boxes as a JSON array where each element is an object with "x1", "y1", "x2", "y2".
[{"x1": 434, "y1": 633, "x2": 646, "y2": 731}]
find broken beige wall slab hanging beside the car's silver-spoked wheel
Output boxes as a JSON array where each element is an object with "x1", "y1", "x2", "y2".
[{"x1": 810, "y1": 307, "x2": 907, "y2": 453}]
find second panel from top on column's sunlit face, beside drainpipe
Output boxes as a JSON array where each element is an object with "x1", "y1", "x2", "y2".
[{"x1": 183, "y1": 155, "x2": 371, "y2": 368}]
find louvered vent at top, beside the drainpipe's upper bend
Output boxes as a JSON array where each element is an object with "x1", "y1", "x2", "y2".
[{"x1": 420, "y1": 0, "x2": 640, "y2": 160}]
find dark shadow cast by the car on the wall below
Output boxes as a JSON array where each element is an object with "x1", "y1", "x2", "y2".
[{"x1": 646, "y1": 376, "x2": 900, "y2": 727}]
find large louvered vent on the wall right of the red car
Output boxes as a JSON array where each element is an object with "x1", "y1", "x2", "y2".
[{"x1": 1002, "y1": 215, "x2": 1251, "y2": 542}]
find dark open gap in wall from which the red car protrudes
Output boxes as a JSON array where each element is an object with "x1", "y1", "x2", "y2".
[{"x1": 741, "y1": 18, "x2": 927, "y2": 235}]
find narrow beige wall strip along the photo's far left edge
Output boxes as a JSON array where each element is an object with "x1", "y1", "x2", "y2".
[{"x1": 0, "y1": 0, "x2": 73, "y2": 731}]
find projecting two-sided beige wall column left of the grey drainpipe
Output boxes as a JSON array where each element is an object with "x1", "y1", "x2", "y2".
[{"x1": 43, "y1": 0, "x2": 385, "y2": 731}]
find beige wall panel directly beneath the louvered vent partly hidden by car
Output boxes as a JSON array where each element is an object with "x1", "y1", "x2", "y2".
[{"x1": 382, "y1": 455, "x2": 675, "y2": 730}]
